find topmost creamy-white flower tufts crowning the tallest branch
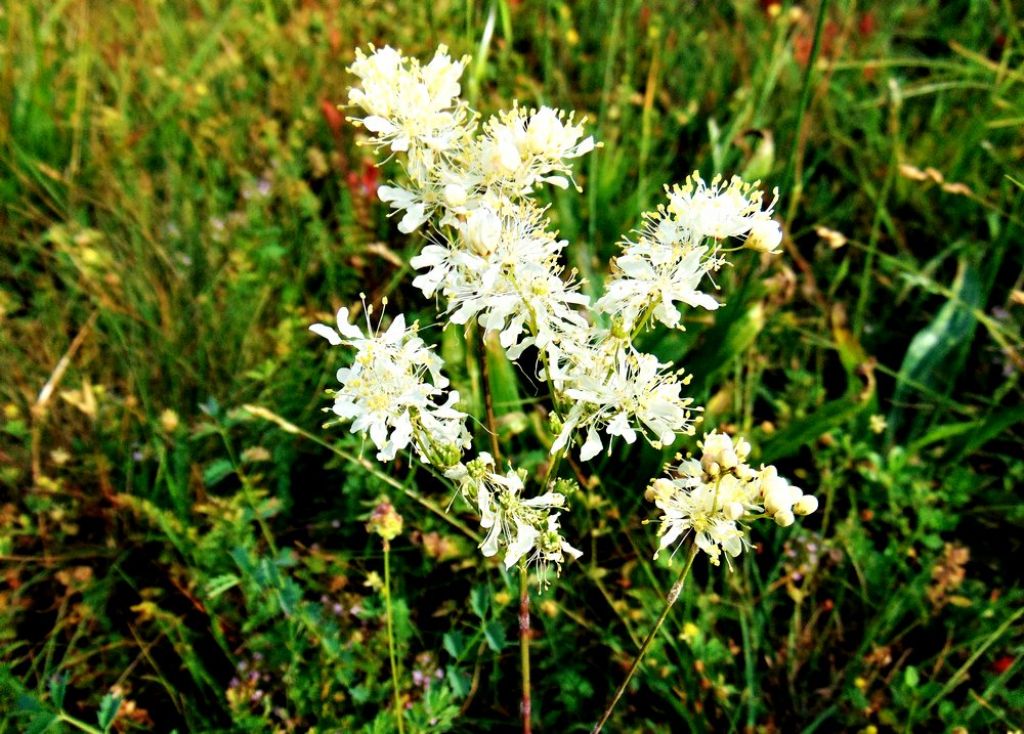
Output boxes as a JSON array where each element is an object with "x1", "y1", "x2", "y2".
[{"x1": 348, "y1": 46, "x2": 594, "y2": 233}]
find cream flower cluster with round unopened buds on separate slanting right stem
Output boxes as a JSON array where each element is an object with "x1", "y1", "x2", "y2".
[{"x1": 647, "y1": 432, "x2": 818, "y2": 565}]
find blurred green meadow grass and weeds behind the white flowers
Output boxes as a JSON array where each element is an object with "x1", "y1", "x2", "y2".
[{"x1": 0, "y1": 0, "x2": 1024, "y2": 732}]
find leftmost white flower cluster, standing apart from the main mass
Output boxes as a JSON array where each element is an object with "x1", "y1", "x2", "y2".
[{"x1": 309, "y1": 308, "x2": 470, "y2": 463}]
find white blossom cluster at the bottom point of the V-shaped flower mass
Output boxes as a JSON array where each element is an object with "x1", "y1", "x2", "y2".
[{"x1": 551, "y1": 338, "x2": 694, "y2": 461}]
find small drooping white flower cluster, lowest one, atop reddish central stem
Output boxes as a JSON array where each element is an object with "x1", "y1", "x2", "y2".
[{"x1": 447, "y1": 451, "x2": 583, "y2": 577}]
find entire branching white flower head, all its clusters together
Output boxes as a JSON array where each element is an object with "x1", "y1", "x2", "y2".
[{"x1": 312, "y1": 41, "x2": 817, "y2": 728}]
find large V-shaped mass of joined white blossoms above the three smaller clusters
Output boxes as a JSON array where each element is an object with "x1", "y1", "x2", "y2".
[{"x1": 349, "y1": 47, "x2": 770, "y2": 460}]
